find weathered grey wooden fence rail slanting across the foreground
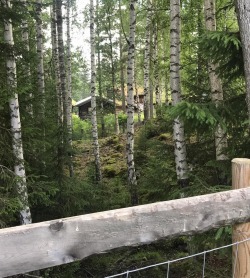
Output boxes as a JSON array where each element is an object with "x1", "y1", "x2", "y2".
[{"x1": 0, "y1": 188, "x2": 250, "y2": 277}]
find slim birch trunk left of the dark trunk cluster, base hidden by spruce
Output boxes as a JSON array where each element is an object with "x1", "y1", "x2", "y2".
[{"x1": 36, "y1": 0, "x2": 45, "y2": 117}]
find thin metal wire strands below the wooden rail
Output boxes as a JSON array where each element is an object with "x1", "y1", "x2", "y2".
[{"x1": 105, "y1": 238, "x2": 250, "y2": 278}]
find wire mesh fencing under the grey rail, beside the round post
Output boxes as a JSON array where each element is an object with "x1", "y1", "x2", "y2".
[{"x1": 105, "y1": 238, "x2": 250, "y2": 278}]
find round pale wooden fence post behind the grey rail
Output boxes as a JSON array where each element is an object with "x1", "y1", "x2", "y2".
[{"x1": 232, "y1": 158, "x2": 250, "y2": 278}]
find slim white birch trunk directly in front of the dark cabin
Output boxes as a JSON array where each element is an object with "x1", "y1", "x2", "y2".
[{"x1": 90, "y1": 0, "x2": 102, "y2": 181}]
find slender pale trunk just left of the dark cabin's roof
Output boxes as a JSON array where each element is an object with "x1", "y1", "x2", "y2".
[{"x1": 66, "y1": 0, "x2": 74, "y2": 177}]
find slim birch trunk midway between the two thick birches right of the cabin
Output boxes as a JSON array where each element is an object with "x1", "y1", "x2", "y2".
[{"x1": 143, "y1": 0, "x2": 152, "y2": 121}]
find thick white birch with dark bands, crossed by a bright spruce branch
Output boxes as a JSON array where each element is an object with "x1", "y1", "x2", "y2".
[{"x1": 170, "y1": 0, "x2": 188, "y2": 186}]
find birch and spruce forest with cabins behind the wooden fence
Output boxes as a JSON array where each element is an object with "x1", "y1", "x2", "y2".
[{"x1": 0, "y1": 0, "x2": 250, "y2": 278}]
